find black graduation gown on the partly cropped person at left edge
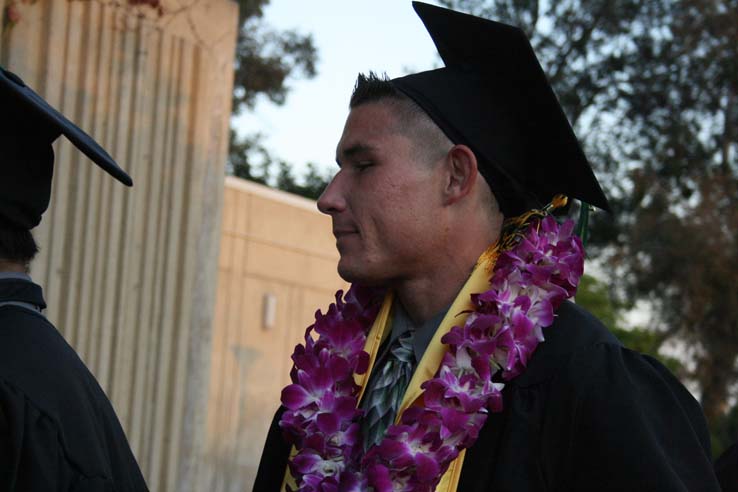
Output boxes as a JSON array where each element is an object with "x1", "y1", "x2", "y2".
[{"x1": 0, "y1": 279, "x2": 148, "y2": 492}]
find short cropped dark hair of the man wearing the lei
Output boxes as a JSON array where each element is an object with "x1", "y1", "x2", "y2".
[{"x1": 349, "y1": 72, "x2": 453, "y2": 161}]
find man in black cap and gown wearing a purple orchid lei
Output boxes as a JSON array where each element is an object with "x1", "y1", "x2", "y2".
[{"x1": 254, "y1": 2, "x2": 719, "y2": 492}]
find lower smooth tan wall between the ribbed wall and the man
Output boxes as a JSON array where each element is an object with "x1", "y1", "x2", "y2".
[{"x1": 198, "y1": 178, "x2": 345, "y2": 492}]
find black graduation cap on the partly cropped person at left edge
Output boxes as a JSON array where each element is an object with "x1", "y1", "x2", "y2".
[{"x1": 0, "y1": 66, "x2": 133, "y2": 229}]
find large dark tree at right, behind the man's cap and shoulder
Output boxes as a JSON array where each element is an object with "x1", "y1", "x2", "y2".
[{"x1": 441, "y1": 0, "x2": 738, "y2": 421}]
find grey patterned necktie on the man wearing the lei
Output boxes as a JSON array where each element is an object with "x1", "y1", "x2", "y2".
[{"x1": 361, "y1": 330, "x2": 415, "y2": 450}]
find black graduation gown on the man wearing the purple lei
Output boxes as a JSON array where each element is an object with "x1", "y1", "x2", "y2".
[{"x1": 254, "y1": 302, "x2": 720, "y2": 492}]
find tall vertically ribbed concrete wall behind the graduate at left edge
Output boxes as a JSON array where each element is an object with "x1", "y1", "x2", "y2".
[{"x1": 0, "y1": 0, "x2": 237, "y2": 492}]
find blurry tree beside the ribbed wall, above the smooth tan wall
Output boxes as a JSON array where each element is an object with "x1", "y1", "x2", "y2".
[{"x1": 228, "y1": 0, "x2": 326, "y2": 195}]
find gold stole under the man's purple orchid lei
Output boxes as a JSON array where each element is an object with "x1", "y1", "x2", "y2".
[{"x1": 281, "y1": 252, "x2": 496, "y2": 492}]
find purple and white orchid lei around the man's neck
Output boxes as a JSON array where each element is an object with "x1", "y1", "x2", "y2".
[{"x1": 280, "y1": 216, "x2": 584, "y2": 492}]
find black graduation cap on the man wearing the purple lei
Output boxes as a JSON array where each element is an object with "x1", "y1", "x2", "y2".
[{"x1": 392, "y1": 2, "x2": 610, "y2": 216}]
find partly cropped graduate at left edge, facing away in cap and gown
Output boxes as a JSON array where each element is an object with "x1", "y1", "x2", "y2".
[{"x1": 0, "y1": 67, "x2": 147, "y2": 492}]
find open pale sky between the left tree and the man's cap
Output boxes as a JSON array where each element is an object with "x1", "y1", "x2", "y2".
[{"x1": 234, "y1": 0, "x2": 440, "y2": 179}]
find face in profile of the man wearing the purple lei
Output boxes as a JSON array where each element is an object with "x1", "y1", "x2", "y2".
[{"x1": 318, "y1": 102, "x2": 444, "y2": 285}]
